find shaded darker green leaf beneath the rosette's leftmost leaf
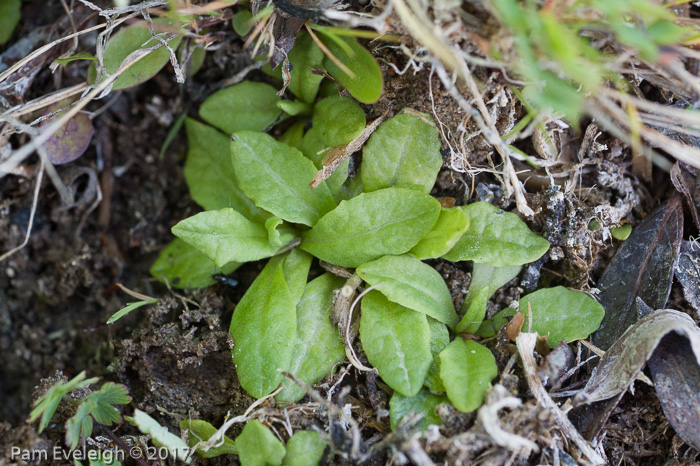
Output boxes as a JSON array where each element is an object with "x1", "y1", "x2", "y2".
[{"x1": 150, "y1": 238, "x2": 241, "y2": 289}]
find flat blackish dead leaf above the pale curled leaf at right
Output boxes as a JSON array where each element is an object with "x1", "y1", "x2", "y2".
[{"x1": 593, "y1": 197, "x2": 683, "y2": 350}]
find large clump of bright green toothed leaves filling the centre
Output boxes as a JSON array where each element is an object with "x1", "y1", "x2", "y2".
[{"x1": 152, "y1": 29, "x2": 602, "y2": 444}]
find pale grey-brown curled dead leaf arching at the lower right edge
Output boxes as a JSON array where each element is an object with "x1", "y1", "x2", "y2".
[{"x1": 574, "y1": 309, "x2": 700, "y2": 404}]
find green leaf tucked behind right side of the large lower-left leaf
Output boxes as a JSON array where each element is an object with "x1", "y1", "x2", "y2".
[{"x1": 277, "y1": 273, "x2": 345, "y2": 402}]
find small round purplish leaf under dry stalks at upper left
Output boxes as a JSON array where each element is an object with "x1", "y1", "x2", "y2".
[{"x1": 42, "y1": 101, "x2": 95, "y2": 165}]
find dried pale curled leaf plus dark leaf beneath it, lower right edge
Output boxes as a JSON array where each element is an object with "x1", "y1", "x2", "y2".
[{"x1": 575, "y1": 303, "x2": 700, "y2": 449}]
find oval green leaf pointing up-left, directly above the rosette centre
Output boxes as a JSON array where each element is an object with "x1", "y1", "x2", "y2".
[{"x1": 231, "y1": 131, "x2": 336, "y2": 226}]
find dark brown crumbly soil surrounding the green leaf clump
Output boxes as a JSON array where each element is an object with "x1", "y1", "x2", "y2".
[{"x1": 0, "y1": 1, "x2": 697, "y2": 465}]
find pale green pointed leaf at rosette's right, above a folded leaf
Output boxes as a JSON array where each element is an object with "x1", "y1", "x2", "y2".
[{"x1": 443, "y1": 202, "x2": 549, "y2": 267}]
